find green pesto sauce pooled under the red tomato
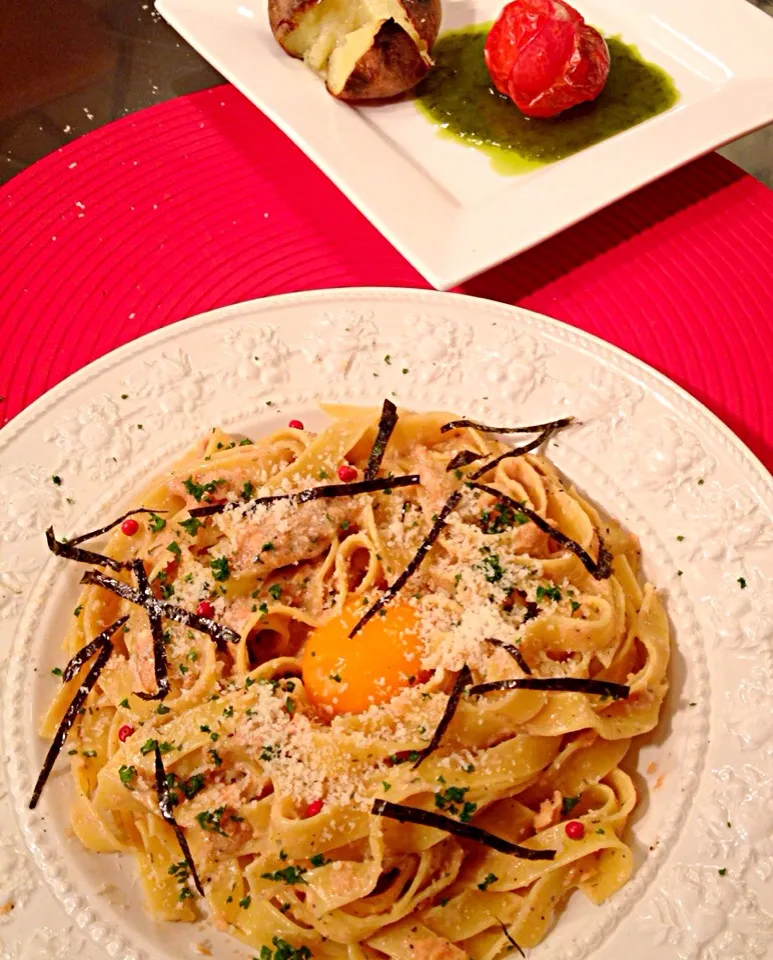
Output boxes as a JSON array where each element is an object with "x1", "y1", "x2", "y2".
[{"x1": 416, "y1": 23, "x2": 679, "y2": 174}]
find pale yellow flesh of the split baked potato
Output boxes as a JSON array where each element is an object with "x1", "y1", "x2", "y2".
[{"x1": 285, "y1": 0, "x2": 430, "y2": 94}]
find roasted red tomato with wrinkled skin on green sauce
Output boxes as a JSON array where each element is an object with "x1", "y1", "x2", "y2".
[{"x1": 484, "y1": 0, "x2": 610, "y2": 118}]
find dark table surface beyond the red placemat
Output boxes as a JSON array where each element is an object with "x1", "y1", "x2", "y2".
[{"x1": 0, "y1": 0, "x2": 773, "y2": 186}]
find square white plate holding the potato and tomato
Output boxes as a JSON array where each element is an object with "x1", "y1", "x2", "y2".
[{"x1": 156, "y1": 0, "x2": 773, "y2": 289}]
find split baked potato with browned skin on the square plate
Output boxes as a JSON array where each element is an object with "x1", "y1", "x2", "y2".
[{"x1": 268, "y1": 0, "x2": 441, "y2": 100}]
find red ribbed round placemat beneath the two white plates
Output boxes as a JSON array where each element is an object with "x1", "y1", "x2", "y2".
[{"x1": 0, "y1": 86, "x2": 773, "y2": 468}]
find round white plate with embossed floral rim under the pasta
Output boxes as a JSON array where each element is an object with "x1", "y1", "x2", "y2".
[{"x1": 0, "y1": 289, "x2": 773, "y2": 960}]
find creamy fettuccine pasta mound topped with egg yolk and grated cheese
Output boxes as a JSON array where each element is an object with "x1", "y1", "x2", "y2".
[{"x1": 42, "y1": 406, "x2": 669, "y2": 960}]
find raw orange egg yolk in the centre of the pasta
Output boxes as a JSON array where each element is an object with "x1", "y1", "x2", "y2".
[{"x1": 303, "y1": 600, "x2": 422, "y2": 714}]
